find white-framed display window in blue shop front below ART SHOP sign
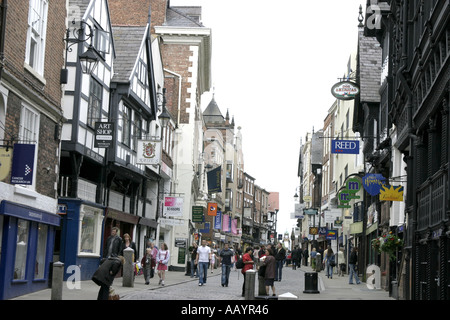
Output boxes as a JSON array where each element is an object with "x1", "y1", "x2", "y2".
[{"x1": 79, "y1": 205, "x2": 103, "y2": 256}]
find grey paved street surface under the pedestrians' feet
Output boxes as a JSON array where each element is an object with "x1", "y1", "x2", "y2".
[{"x1": 10, "y1": 266, "x2": 395, "y2": 301}]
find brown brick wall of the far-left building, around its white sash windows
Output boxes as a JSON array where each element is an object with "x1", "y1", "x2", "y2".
[{"x1": 1, "y1": 0, "x2": 66, "y2": 198}]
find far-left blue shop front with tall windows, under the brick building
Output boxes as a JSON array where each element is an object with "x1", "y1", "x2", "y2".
[{"x1": 0, "y1": 200, "x2": 60, "y2": 300}]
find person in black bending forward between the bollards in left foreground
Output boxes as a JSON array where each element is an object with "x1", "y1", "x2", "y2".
[{"x1": 92, "y1": 256, "x2": 125, "y2": 300}]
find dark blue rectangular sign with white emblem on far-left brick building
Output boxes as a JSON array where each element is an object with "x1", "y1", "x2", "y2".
[{"x1": 11, "y1": 143, "x2": 36, "y2": 185}]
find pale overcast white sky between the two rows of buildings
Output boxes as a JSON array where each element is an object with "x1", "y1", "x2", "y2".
[{"x1": 170, "y1": 0, "x2": 366, "y2": 233}]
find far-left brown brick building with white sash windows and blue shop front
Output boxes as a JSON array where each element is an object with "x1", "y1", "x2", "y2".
[{"x1": 0, "y1": 0, "x2": 66, "y2": 299}]
